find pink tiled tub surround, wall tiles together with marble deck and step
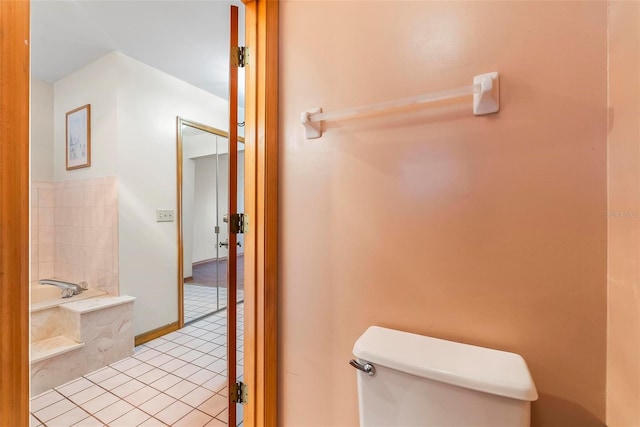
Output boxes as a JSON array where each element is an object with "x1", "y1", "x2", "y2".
[{"x1": 31, "y1": 177, "x2": 133, "y2": 394}]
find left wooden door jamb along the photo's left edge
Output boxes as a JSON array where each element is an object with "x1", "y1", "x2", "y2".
[{"x1": 0, "y1": 1, "x2": 30, "y2": 426}]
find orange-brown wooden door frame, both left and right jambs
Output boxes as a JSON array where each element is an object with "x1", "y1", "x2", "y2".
[{"x1": 0, "y1": 0, "x2": 279, "y2": 426}]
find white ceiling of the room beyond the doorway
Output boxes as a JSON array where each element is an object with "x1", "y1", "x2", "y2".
[{"x1": 31, "y1": 0, "x2": 244, "y2": 99}]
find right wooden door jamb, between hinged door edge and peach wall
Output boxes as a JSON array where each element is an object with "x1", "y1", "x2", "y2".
[{"x1": 244, "y1": 0, "x2": 279, "y2": 426}]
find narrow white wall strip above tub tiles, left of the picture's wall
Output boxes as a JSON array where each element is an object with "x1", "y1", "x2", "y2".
[{"x1": 31, "y1": 78, "x2": 53, "y2": 182}]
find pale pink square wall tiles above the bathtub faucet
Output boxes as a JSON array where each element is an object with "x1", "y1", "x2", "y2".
[{"x1": 31, "y1": 177, "x2": 119, "y2": 295}]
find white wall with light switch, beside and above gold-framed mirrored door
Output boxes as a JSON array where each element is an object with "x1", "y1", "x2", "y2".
[{"x1": 118, "y1": 55, "x2": 241, "y2": 334}]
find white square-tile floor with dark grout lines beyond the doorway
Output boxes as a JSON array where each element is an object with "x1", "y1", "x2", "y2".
[{"x1": 31, "y1": 304, "x2": 244, "y2": 427}]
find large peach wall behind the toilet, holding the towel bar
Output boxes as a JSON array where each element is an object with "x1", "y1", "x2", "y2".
[{"x1": 278, "y1": 1, "x2": 607, "y2": 427}]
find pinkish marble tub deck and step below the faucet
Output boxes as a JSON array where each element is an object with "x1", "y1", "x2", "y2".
[{"x1": 31, "y1": 296, "x2": 134, "y2": 395}]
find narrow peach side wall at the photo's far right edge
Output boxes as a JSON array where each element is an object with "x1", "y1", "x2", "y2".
[{"x1": 607, "y1": 1, "x2": 640, "y2": 427}]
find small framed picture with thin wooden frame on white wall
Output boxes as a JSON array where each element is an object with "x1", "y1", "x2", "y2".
[{"x1": 66, "y1": 104, "x2": 91, "y2": 170}]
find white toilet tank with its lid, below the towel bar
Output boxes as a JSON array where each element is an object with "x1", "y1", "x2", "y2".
[{"x1": 351, "y1": 326, "x2": 538, "y2": 427}]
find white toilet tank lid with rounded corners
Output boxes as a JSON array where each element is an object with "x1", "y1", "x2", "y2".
[{"x1": 353, "y1": 326, "x2": 538, "y2": 401}]
